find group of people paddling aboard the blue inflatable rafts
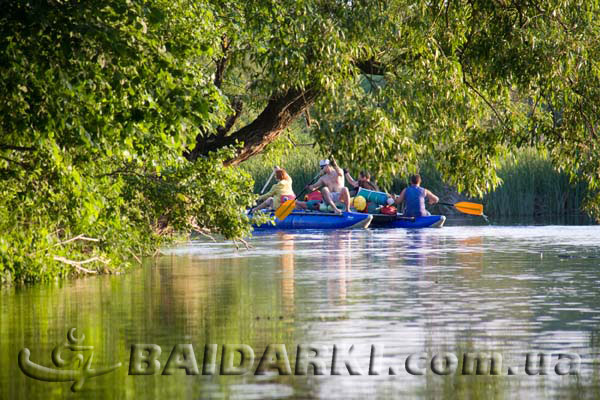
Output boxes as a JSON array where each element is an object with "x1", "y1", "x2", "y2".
[{"x1": 252, "y1": 160, "x2": 439, "y2": 217}]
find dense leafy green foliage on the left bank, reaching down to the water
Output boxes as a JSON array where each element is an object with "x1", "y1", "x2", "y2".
[{"x1": 0, "y1": 1, "x2": 260, "y2": 281}]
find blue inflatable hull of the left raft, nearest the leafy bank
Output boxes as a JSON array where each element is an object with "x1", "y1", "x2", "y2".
[{"x1": 254, "y1": 211, "x2": 373, "y2": 230}]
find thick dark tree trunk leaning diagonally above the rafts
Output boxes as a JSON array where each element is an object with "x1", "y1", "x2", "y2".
[{"x1": 186, "y1": 89, "x2": 318, "y2": 165}]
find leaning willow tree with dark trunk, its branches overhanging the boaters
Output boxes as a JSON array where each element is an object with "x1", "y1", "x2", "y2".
[{"x1": 188, "y1": 0, "x2": 600, "y2": 206}]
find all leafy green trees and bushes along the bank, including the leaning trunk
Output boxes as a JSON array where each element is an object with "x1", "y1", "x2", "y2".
[{"x1": 0, "y1": 0, "x2": 600, "y2": 282}]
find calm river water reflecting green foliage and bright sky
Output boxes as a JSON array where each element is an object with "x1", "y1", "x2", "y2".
[{"x1": 0, "y1": 226, "x2": 600, "y2": 399}]
